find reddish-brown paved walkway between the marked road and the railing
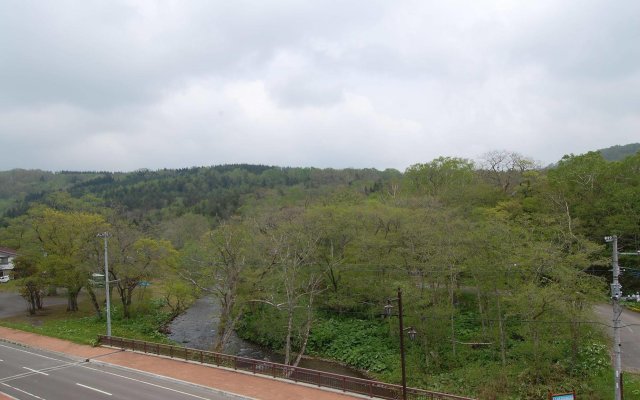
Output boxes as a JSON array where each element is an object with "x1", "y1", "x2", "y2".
[{"x1": 0, "y1": 327, "x2": 358, "y2": 400}]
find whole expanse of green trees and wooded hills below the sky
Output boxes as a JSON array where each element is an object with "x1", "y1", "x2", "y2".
[{"x1": 0, "y1": 148, "x2": 640, "y2": 399}]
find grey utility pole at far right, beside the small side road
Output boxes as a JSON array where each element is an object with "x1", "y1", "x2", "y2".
[{"x1": 605, "y1": 235, "x2": 622, "y2": 400}]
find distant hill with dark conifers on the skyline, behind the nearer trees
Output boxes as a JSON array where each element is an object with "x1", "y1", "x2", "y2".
[{"x1": 0, "y1": 164, "x2": 401, "y2": 223}]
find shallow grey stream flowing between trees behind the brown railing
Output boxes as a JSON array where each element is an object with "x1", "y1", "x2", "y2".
[{"x1": 168, "y1": 296, "x2": 367, "y2": 379}]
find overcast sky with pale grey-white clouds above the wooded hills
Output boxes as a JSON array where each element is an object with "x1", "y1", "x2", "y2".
[{"x1": 0, "y1": 0, "x2": 640, "y2": 171}]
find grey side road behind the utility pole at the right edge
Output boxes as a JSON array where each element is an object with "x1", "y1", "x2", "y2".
[{"x1": 595, "y1": 304, "x2": 640, "y2": 372}]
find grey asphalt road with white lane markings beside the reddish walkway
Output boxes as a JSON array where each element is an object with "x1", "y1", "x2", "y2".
[{"x1": 0, "y1": 342, "x2": 245, "y2": 400}]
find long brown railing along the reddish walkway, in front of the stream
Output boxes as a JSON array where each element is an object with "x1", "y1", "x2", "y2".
[{"x1": 98, "y1": 335, "x2": 474, "y2": 400}]
